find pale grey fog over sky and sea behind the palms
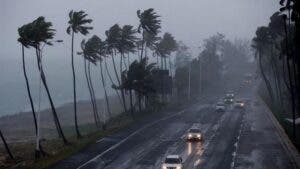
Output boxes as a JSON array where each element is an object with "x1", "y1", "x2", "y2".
[{"x1": 0, "y1": 0, "x2": 279, "y2": 115}]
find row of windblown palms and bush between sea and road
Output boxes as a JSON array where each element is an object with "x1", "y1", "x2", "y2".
[{"x1": 0, "y1": 8, "x2": 177, "y2": 168}]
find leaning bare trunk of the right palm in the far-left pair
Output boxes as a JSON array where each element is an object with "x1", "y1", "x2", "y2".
[{"x1": 36, "y1": 46, "x2": 69, "y2": 145}]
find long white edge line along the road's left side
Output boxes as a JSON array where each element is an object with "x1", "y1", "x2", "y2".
[{"x1": 77, "y1": 110, "x2": 185, "y2": 169}]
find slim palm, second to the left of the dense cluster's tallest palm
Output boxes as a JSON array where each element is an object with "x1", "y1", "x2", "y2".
[{"x1": 105, "y1": 24, "x2": 127, "y2": 112}]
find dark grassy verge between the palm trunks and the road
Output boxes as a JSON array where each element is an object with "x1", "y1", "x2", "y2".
[{"x1": 0, "y1": 105, "x2": 168, "y2": 169}]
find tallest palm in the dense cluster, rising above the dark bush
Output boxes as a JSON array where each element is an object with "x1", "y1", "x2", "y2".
[{"x1": 137, "y1": 8, "x2": 161, "y2": 60}]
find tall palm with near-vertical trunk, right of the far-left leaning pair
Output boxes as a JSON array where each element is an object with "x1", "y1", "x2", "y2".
[{"x1": 67, "y1": 10, "x2": 93, "y2": 138}]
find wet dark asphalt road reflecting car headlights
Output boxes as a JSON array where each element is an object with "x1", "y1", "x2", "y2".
[{"x1": 51, "y1": 83, "x2": 296, "y2": 169}]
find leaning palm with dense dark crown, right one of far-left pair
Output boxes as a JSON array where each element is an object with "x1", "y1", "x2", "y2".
[{"x1": 24, "y1": 16, "x2": 68, "y2": 144}]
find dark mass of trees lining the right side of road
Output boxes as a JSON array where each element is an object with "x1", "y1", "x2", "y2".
[{"x1": 252, "y1": 0, "x2": 300, "y2": 149}]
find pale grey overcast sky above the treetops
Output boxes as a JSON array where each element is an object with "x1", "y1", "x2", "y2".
[{"x1": 0, "y1": 0, "x2": 278, "y2": 57}]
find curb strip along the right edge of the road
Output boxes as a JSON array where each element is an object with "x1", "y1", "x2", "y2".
[{"x1": 258, "y1": 97, "x2": 300, "y2": 169}]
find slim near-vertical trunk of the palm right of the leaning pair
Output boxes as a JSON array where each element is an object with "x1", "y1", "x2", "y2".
[{"x1": 71, "y1": 31, "x2": 81, "y2": 138}]
